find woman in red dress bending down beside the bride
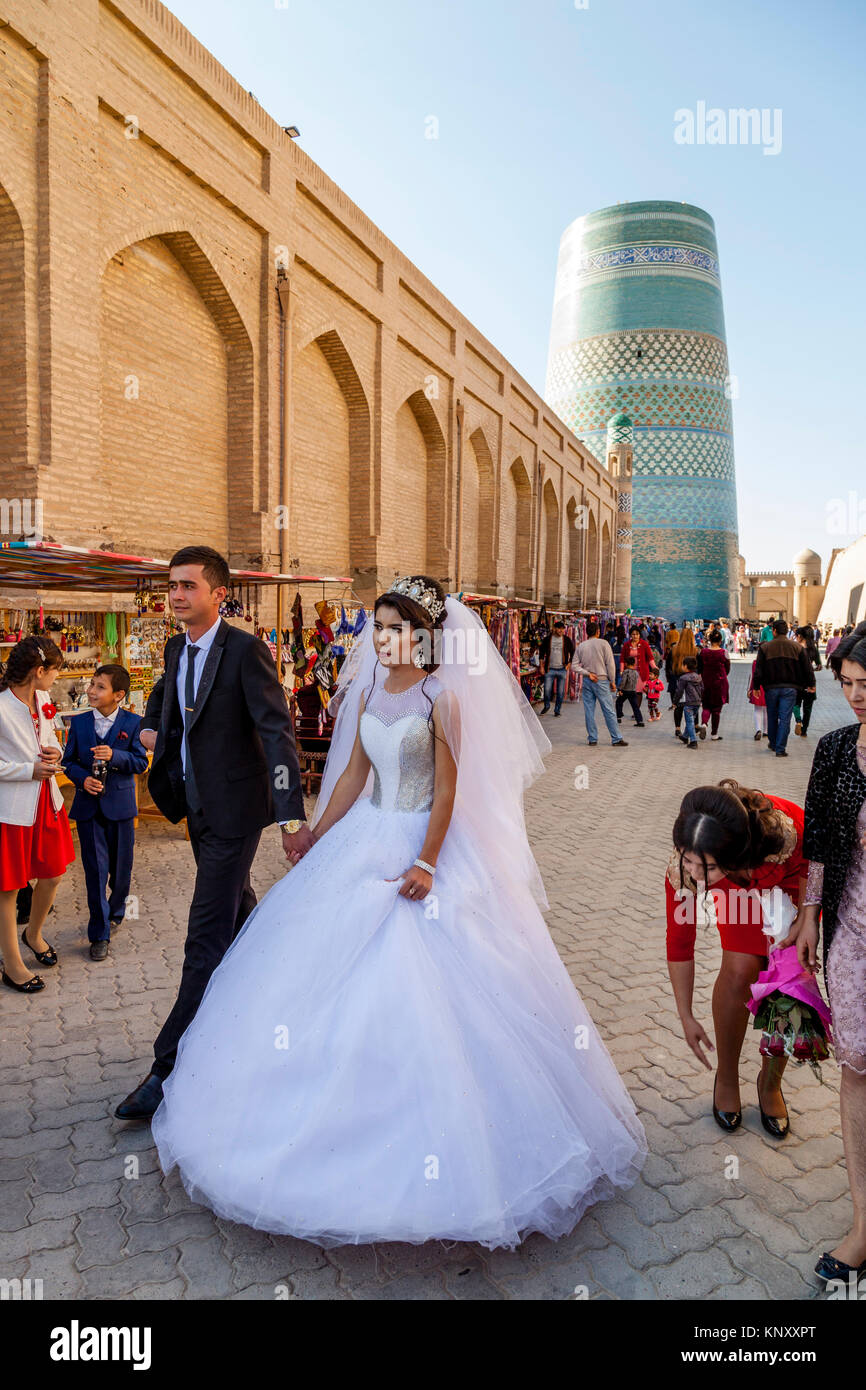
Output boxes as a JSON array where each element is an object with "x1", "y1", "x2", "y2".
[{"x1": 664, "y1": 780, "x2": 806, "y2": 1138}]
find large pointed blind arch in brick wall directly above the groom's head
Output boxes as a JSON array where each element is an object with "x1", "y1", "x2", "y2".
[{"x1": 100, "y1": 231, "x2": 255, "y2": 555}]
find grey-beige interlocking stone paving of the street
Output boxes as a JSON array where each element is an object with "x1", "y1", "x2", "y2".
[{"x1": 0, "y1": 663, "x2": 851, "y2": 1300}]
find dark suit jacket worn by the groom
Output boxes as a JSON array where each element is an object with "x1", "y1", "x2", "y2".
[{"x1": 142, "y1": 621, "x2": 306, "y2": 838}]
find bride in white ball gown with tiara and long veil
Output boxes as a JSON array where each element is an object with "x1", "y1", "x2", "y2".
[{"x1": 152, "y1": 575, "x2": 646, "y2": 1248}]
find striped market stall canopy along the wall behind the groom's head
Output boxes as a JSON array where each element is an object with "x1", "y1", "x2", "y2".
[{"x1": 0, "y1": 541, "x2": 352, "y2": 594}]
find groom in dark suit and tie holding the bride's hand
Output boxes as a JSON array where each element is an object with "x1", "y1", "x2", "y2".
[{"x1": 114, "y1": 545, "x2": 313, "y2": 1119}]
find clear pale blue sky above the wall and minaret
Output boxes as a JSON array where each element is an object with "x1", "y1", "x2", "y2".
[{"x1": 170, "y1": 0, "x2": 866, "y2": 569}]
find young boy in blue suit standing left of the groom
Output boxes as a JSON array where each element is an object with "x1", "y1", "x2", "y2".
[{"x1": 63, "y1": 666, "x2": 147, "y2": 960}]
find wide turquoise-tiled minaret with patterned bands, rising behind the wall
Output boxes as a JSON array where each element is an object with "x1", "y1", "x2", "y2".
[{"x1": 546, "y1": 202, "x2": 738, "y2": 619}]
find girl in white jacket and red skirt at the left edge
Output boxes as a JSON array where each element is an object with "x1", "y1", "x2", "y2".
[{"x1": 0, "y1": 637, "x2": 75, "y2": 994}]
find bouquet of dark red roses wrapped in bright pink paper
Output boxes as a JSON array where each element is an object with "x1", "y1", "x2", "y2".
[{"x1": 746, "y1": 945, "x2": 833, "y2": 1081}]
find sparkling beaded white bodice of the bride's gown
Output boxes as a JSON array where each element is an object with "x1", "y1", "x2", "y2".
[{"x1": 360, "y1": 676, "x2": 442, "y2": 810}]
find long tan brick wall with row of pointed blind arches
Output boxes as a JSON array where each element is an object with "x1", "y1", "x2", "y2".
[{"x1": 0, "y1": 0, "x2": 616, "y2": 602}]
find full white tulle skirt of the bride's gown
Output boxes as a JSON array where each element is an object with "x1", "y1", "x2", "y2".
[{"x1": 153, "y1": 799, "x2": 646, "y2": 1248}]
